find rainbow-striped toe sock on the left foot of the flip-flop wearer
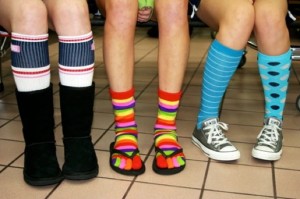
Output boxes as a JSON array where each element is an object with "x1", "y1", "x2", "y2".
[{"x1": 110, "y1": 89, "x2": 142, "y2": 170}]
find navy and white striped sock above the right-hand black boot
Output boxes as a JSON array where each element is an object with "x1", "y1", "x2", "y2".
[{"x1": 58, "y1": 32, "x2": 95, "y2": 87}]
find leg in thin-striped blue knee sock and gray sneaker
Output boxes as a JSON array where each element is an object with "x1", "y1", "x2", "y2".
[{"x1": 192, "y1": 0, "x2": 254, "y2": 161}]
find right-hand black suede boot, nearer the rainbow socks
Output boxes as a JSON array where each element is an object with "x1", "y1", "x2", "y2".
[{"x1": 60, "y1": 84, "x2": 98, "y2": 180}]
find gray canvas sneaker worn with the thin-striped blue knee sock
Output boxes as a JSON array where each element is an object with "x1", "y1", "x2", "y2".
[{"x1": 192, "y1": 118, "x2": 240, "y2": 161}]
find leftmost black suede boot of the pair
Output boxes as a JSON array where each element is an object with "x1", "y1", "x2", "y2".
[{"x1": 16, "y1": 86, "x2": 63, "y2": 186}]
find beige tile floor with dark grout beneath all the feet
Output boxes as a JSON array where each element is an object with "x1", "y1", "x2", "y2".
[{"x1": 0, "y1": 27, "x2": 300, "y2": 199}]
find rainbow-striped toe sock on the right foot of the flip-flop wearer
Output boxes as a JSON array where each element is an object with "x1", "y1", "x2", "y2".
[{"x1": 154, "y1": 89, "x2": 185, "y2": 169}]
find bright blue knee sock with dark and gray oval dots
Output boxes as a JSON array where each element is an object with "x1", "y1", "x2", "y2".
[{"x1": 258, "y1": 50, "x2": 292, "y2": 120}]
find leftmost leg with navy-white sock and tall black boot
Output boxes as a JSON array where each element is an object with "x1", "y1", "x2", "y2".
[{"x1": 0, "y1": 0, "x2": 62, "y2": 186}]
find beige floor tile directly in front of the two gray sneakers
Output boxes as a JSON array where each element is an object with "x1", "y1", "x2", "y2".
[{"x1": 205, "y1": 163, "x2": 273, "y2": 196}]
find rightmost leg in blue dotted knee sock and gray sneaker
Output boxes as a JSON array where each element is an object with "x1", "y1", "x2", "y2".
[{"x1": 252, "y1": 0, "x2": 292, "y2": 160}]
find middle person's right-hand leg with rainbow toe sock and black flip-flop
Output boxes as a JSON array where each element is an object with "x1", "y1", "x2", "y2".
[{"x1": 149, "y1": 0, "x2": 189, "y2": 175}]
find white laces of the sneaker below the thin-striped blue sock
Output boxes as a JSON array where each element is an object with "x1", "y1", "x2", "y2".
[{"x1": 203, "y1": 122, "x2": 229, "y2": 147}]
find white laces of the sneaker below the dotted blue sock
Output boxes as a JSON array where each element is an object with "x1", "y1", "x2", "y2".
[{"x1": 257, "y1": 125, "x2": 281, "y2": 148}]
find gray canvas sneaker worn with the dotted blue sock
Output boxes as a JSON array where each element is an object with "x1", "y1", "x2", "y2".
[{"x1": 252, "y1": 117, "x2": 283, "y2": 161}]
